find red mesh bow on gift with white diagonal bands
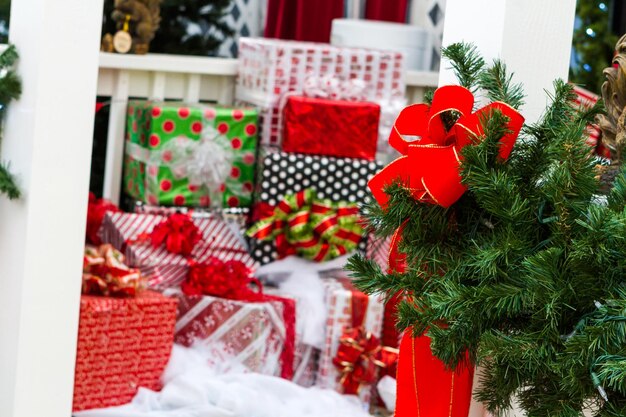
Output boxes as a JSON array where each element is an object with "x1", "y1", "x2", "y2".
[{"x1": 181, "y1": 258, "x2": 263, "y2": 301}]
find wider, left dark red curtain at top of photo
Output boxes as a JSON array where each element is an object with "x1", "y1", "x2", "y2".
[{"x1": 265, "y1": 0, "x2": 344, "y2": 42}]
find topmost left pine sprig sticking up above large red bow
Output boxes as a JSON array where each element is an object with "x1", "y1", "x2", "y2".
[{"x1": 441, "y1": 42, "x2": 485, "y2": 93}]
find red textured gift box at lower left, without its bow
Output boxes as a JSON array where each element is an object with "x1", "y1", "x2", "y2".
[{"x1": 73, "y1": 291, "x2": 177, "y2": 411}]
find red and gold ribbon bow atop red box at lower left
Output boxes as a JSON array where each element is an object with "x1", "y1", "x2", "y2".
[{"x1": 82, "y1": 244, "x2": 145, "y2": 297}]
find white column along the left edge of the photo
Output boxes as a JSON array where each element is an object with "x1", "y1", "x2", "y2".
[{"x1": 0, "y1": 0, "x2": 103, "y2": 417}]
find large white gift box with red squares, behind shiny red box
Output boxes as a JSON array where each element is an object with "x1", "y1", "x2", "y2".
[{"x1": 235, "y1": 38, "x2": 405, "y2": 145}]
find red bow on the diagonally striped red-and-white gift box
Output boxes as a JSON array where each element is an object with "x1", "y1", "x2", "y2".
[{"x1": 146, "y1": 213, "x2": 202, "y2": 256}]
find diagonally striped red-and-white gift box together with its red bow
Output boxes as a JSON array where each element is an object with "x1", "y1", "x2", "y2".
[{"x1": 101, "y1": 213, "x2": 257, "y2": 289}]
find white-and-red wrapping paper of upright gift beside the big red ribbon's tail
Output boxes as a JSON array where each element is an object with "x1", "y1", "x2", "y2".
[{"x1": 316, "y1": 271, "x2": 384, "y2": 404}]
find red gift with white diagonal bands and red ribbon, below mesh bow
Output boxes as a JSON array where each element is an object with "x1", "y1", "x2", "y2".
[{"x1": 166, "y1": 290, "x2": 295, "y2": 379}]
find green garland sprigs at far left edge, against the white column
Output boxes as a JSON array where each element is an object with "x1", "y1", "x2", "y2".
[{"x1": 0, "y1": 45, "x2": 22, "y2": 199}]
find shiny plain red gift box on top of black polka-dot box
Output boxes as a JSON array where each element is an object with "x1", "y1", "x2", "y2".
[{"x1": 283, "y1": 96, "x2": 380, "y2": 160}]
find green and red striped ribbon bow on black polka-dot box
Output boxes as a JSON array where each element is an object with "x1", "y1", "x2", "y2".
[{"x1": 248, "y1": 189, "x2": 363, "y2": 262}]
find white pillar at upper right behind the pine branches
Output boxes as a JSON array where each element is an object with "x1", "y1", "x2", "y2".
[{"x1": 439, "y1": 0, "x2": 576, "y2": 123}]
